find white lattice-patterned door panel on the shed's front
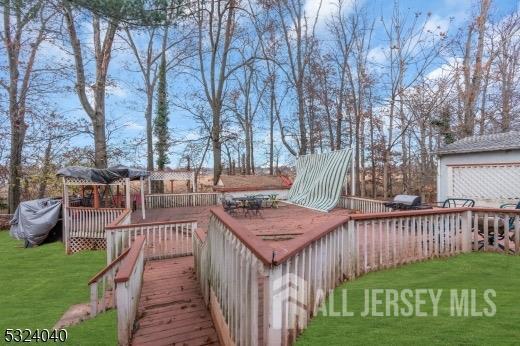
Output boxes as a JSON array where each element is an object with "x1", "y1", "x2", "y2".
[{"x1": 448, "y1": 163, "x2": 520, "y2": 202}]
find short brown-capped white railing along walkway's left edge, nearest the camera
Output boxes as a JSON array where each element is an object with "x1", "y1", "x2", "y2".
[{"x1": 114, "y1": 236, "x2": 145, "y2": 345}]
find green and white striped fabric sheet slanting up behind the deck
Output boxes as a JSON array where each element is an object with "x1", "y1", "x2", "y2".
[{"x1": 287, "y1": 149, "x2": 352, "y2": 212}]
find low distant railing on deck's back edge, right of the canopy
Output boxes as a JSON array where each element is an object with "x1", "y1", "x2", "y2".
[{"x1": 145, "y1": 192, "x2": 220, "y2": 208}]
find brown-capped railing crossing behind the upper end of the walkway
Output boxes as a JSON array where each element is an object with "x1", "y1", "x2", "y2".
[{"x1": 106, "y1": 220, "x2": 197, "y2": 261}]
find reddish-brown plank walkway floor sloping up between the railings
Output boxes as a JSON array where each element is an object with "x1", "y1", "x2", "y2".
[{"x1": 132, "y1": 256, "x2": 219, "y2": 346}]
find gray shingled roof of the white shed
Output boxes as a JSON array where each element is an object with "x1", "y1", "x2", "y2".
[{"x1": 437, "y1": 131, "x2": 520, "y2": 155}]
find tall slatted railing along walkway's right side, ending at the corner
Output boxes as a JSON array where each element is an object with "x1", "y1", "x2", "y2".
[{"x1": 195, "y1": 211, "x2": 269, "y2": 345}]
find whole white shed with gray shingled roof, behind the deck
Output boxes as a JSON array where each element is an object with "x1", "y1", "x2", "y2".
[{"x1": 437, "y1": 132, "x2": 520, "y2": 207}]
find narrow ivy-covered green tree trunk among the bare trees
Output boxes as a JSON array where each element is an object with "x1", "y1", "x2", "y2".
[{"x1": 154, "y1": 52, "x2": 170, "y2": 170}]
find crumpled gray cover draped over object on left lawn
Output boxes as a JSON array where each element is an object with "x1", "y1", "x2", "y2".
[{"x1": 9, "y1": 198, "x2": 61, "y2": 245}]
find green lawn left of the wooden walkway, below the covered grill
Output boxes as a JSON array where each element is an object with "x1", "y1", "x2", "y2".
[{"x1": 0, "y1": 232, "x2": 117, "y2": 345}]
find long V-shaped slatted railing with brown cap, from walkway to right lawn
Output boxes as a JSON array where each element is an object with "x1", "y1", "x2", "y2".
[{"x1": 195, "y1": 208, "x2": 496, "y2": 345}]
